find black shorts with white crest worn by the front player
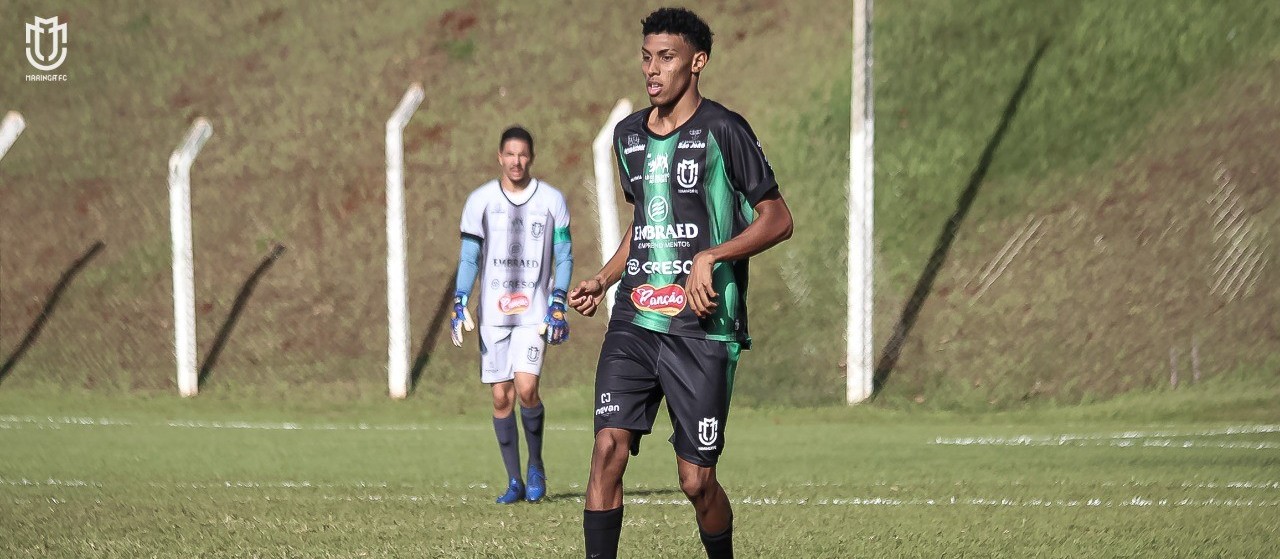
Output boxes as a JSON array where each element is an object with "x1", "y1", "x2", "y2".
[{"x1": 595, "y1": 321, "x2": 741, "y2": 467}]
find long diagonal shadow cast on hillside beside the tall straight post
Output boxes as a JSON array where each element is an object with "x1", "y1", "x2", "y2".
[{"x1": 872, "y1": 40, "x2": 1050, "y2": 395}]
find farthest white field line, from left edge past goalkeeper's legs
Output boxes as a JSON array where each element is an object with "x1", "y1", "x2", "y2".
[{"x1": 0, "y1": 416, "x2": 589, "y2": 431}]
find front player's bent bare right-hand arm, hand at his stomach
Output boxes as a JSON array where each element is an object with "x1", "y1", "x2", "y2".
[{"x1": 685, "y1": 189, "x2": 794, "y2": 319}]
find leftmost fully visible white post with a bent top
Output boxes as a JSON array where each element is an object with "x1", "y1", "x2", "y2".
[{"x1": 169, "y1": 118, "x2": 214, "y2": 397}]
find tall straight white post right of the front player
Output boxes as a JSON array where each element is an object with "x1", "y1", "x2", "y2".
[{"x1": 845, "y1": 0, "x2": 876, "y2": 404}]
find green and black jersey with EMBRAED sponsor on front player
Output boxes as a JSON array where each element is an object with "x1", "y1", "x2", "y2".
[{"x1": 613, "y1": 98, "x2": 778, "y2": 348}]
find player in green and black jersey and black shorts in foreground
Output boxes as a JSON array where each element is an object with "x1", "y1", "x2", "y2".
[{"x1": 570, "y1": 8, "x2": 792, "y2": 558}]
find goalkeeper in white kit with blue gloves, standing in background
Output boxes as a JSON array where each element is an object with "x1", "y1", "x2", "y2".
[{"x1": 451, "y1": 127, "x2": 573, "y2": 504}]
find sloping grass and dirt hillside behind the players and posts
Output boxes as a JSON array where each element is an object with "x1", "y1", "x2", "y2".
[{"x1": 0, "y1": 0, "x2": 1280, "y2": 407}]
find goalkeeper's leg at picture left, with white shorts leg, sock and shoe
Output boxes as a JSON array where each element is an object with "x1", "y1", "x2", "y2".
[{"x1": 479, "y1": 326, "x2": 525, "y2": 504}]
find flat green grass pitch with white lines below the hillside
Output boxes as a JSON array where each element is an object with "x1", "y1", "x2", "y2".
[{"x1": 0, "y1": 382, "x2": 1280, "y2": 558}]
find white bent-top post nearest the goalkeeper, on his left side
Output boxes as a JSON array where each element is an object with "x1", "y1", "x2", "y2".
[{"x1": 387, "y1": 83, "x2": 426, "y2": 399}]
